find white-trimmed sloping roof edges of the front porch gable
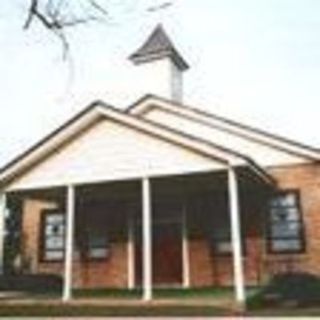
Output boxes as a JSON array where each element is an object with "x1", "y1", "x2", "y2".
[{"x1": 0, "y1": 101, "x2": 270, "y2": 188}]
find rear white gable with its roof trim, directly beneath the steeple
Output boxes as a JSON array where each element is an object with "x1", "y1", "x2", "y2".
[{"x1": 127, "y1": 95, "x2": 320, "y2": 166}]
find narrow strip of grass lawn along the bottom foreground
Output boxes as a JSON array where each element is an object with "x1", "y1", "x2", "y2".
[{"x1": 0, "y1": 304, "x2": 320, "y2": 317}]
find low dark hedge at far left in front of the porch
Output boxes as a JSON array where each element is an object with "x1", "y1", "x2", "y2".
[{"x1": 0, "y1": 274, "x2": 62, "y2": 293}]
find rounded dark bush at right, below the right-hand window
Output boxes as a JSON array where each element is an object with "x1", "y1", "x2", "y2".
[{"x1": 248, "y1": 273, "x2": 320, "y2": 307}]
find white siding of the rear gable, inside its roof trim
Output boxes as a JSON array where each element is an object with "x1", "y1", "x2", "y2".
[{"x1": 144, "y1": 108, "x2": 305, "y2": 166}]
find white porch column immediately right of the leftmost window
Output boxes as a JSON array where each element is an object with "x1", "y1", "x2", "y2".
[{"x1": 62, "y1": 185, "x2": 75, "y2": 301}]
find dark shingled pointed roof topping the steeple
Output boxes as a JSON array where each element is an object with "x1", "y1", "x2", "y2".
[{"x1": 129, "y1": 24, "x2": 189, "y2": 70}]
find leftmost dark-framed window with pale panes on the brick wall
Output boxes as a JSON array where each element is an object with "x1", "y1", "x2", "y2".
[{"x1": 42, "y1": 211, "x2": 65, "y2": 261}]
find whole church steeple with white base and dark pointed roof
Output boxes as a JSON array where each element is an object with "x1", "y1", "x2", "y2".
[{"x1": 129, "y1": 24, "x2": 189, "y2": 102}]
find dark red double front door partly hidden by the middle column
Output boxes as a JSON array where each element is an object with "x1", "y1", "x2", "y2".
[{"x1": 135, "y1": 221, "x2": 182, "y2": 286}]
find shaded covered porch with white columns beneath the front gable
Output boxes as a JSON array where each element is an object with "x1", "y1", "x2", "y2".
[{"x1": 2, "y1": 167, "x2": 270, "y2": 304}]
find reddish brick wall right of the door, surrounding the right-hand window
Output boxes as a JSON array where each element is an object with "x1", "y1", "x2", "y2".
[{"x1": 189, "y1": 164, "x2": 320, "y2": 287}]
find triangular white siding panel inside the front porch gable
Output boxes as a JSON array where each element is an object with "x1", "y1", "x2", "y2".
[{"x1": 8, "y1": 120, "x2": 221, "y2": 190}]
